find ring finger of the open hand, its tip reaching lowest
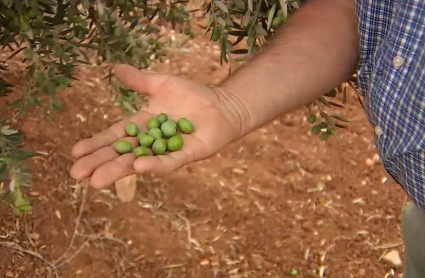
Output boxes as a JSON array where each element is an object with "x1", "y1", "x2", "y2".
[{"x1": 90, "y1": 153, "x2": 136, "y2": 188}]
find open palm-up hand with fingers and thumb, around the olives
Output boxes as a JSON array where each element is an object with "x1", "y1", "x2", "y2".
[{"x1": 71, "y1": 65, "x2": 238, "y2": 188}]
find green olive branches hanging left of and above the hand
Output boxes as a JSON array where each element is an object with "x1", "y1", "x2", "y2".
[{"x1": 0, "y1": 0, "x2": 192, "y2": 214}]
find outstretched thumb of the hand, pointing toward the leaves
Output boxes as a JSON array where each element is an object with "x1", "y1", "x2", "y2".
[{"x1": 114, "y1": 64, "x2": 168, "y2": 95}]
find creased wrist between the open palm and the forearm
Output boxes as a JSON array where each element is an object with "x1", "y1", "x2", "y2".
[{"x1": 212, "y1": 86, "x2": 254, "y2": 141}]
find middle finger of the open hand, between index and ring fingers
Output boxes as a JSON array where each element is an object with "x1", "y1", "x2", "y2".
[{"x1": 71, "y1": 137, "x2": 137, "y2": 180}]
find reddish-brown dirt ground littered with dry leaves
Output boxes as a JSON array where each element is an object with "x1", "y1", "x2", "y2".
[{"x1": 0, "y1": 17, "x2": 406, "y2": 278}]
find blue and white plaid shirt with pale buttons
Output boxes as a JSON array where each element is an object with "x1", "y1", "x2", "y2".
[{"x1": 356, "y1": 0, "x2": 425, "y2": 211}]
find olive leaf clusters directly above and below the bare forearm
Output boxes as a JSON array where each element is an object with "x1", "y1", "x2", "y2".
[{"x1": 202, "y1": 0, "x2": 356, "y2": 141}]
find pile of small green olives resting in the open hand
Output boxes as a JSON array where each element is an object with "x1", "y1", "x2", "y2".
[{"x1": 114, "y1": 113, "x2": 194, "y2": 157}]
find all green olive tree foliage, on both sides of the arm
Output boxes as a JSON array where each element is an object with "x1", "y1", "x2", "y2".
[{"x1": 0, "y1": 0, "x2": 355, "y2": 215}]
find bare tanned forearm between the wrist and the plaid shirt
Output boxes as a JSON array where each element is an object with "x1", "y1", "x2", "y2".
[{"x1": 216, "y1": 0, "x2": 359, "y2": 136}]
